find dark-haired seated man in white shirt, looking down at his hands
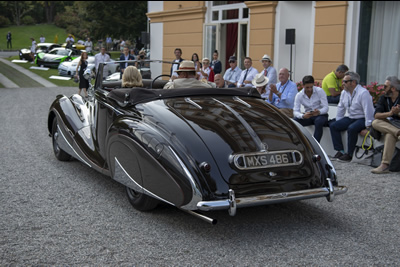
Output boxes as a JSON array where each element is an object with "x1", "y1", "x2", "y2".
[{"x1": 293, "y1": 75, "x2": 329, "y2": 142}]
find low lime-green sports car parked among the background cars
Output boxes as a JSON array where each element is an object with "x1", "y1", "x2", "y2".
[{"x1": 36, "y1": 47, "x2": 81, "y2": 68}]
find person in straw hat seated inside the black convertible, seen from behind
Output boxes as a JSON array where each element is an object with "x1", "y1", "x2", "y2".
[{"x1": 164, "y1": 60, "x2": 212, "y2": 89}]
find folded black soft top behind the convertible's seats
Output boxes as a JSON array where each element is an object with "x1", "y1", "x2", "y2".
[{"x1": 107, "y1": 87, "x2": 261, "y2": 105}]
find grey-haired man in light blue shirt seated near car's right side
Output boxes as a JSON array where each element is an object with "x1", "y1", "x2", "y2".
[{"x1": 267, "y1": 68, "x2": 297, "y2": 118}]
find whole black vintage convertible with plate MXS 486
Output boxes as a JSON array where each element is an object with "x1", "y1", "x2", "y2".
[{"x1": 48, "y1": 62, "x2": 347, "y2": 223}]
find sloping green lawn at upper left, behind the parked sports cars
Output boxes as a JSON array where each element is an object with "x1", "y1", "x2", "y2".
[{"x1": 0, "y1": 24, "x2": 68, "y2": 50}]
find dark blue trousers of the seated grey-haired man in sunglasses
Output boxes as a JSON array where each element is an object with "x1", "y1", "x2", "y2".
[{"x1": 329, "y1": 117, "x2": 365, "y2": 156}]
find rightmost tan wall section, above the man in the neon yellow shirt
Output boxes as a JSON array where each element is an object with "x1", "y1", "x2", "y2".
[{"x1": 313, "y1": 1, "x2": 348, "y2": 81}]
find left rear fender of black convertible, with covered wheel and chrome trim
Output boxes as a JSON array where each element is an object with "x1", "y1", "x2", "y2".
[{"x1": 107, "y1": 116, "x2": 223, "y2": 209}]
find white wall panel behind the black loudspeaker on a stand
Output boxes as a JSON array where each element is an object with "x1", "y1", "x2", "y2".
[{"x1": 273, "y1": 1, "x2": 315, "y2": 82}]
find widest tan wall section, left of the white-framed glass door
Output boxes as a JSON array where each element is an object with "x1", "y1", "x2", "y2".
[{"x1": 147, "y1": 1, "x2": 207, "y2": 74}]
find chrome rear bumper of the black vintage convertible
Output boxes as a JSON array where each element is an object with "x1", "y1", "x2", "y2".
[{"x1": 197, "y1": 178, "x2": 347, "y2": 216}]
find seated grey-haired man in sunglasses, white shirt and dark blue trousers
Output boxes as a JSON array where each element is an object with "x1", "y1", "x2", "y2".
[{"x1": 329, "y1": 71, "x2": 375, "y2": 162}]
